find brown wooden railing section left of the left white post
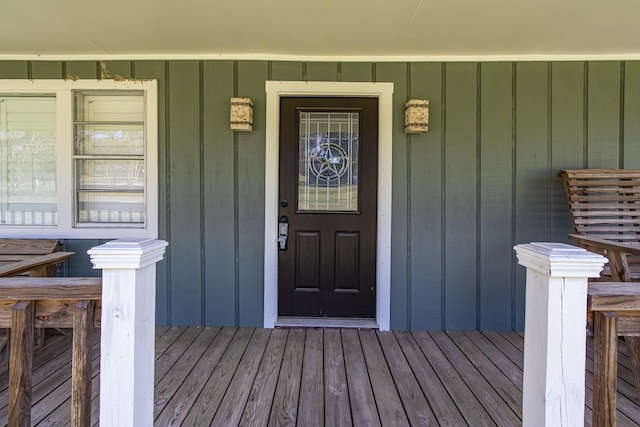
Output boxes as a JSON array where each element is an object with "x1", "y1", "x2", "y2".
[{"x1": 0, "y1": 277, "x2": 102, "y2": 426}]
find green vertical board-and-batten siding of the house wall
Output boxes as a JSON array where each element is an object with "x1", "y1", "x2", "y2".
[{"x1": 0, "y1": 60, "x2": 640, "y2": 329}]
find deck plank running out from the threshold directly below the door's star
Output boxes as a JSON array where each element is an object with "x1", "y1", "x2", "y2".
[{"x1": 324, "y1": 329, "x2": 353, "y2": 426}]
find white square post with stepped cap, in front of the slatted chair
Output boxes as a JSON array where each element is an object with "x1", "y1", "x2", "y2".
[{"x1": 514, "y1": 243, "x2": 606, "y2": 427}]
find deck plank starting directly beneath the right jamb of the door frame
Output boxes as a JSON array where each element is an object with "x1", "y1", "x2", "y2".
[{"x1": 377, "y1": 332, "x2": 436, "y2": 426}]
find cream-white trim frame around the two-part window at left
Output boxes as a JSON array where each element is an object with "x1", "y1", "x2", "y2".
[{"x1": 0, "y1": 79, "x2": 158, "y2": 239}]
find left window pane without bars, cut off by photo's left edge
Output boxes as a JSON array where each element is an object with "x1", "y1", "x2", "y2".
[{"x1": 0, "y1": 95, "x2": 57, "y2": 226}]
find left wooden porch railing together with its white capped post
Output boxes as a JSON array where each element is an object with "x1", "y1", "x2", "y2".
[{"x1": 0, "y1": 239, "x2": 167, "y2": 427}]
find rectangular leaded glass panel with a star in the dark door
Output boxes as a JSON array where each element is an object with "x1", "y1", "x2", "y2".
[{"x1": 298, "y1": 112, "x2": 359, "y2": 212}]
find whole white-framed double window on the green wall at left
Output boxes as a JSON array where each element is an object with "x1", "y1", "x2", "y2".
[{"x1": 0, "y1": 80, "x2": 158, "y2": 238}]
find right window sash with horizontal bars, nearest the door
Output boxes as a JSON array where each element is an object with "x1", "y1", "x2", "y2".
[{"x1": 73, "y1": 91, "x2": 145, "y2": 227}]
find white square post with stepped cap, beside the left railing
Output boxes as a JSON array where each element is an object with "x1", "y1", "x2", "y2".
[{"x1": 88, "y1": 239, "x2": 167, "y2": 427}]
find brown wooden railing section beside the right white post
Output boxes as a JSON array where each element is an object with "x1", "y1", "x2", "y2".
[{"x1": 587, "y1": 282, "x2": 640, "y2": 427}]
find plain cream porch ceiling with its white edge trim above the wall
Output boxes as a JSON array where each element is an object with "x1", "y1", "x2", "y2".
[{"x1": 0, "y1": 0, "x2": 640, "y2": 60}]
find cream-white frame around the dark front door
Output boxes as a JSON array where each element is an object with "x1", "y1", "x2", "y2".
[{"x1": 264, "y1": 81, "x2": 393, "y2": 331}]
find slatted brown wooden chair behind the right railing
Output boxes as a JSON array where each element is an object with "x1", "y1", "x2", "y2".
[{"x1": 558, "y1": 169, "x2": 640, "y2": 406}]
